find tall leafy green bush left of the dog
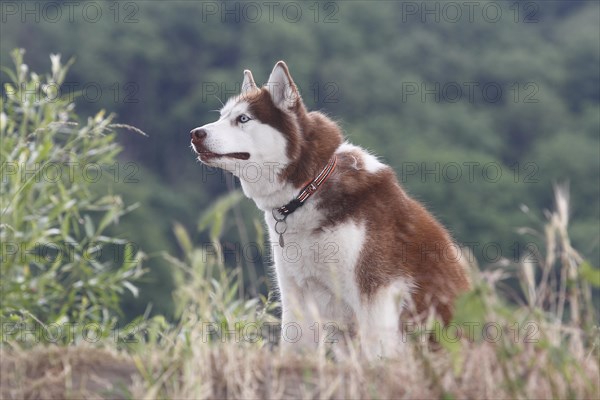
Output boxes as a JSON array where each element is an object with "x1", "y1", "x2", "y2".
[{"x1": 0, "y1": 50, "x2": 143, "y2": 342}]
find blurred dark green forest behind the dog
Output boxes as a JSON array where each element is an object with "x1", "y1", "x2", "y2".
[{"x1": 0, "y1": 1, "x2": 600, "y2": 317}]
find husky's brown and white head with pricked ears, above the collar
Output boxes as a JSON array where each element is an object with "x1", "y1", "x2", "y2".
[{"x1": 191, "y1": 61, "x2": 341, "y2": 188}]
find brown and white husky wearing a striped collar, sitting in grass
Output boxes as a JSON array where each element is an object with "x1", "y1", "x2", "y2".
[{"x1": 191, "y1": 61, "x2": 469, "y2": 358}]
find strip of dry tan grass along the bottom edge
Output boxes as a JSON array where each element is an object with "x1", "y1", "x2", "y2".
[{"x1": 1, "y1": 342, "x2": 600, "y2": 399}]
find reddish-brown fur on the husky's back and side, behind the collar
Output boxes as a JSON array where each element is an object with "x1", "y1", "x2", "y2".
[{"x1": 318, "y1": 153, "x2": 469, "y2": 323}]
